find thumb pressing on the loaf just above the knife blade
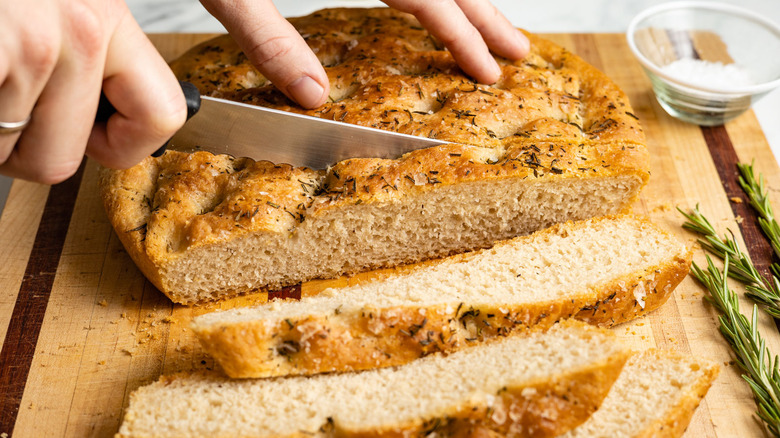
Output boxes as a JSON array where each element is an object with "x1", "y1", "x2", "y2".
[{"x1": 201, "y1": 0, "x2": 330, "y2": 108}]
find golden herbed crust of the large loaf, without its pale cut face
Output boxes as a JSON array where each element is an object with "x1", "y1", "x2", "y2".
[{"x1": 101, "y1": 9, "x2": 649, "y2": 302}]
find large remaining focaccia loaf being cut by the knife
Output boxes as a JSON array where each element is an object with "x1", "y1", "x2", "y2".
[{"x1": 101, "y1": 8, "x2": 649, "y2": 304}]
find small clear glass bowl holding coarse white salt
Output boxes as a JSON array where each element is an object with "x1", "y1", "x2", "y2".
[{"x1": 627, "y1": 1, "x2": 780, "y2": 126}]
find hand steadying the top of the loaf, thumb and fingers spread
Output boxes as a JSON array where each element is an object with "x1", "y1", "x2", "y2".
[{"x1": 201, "y1": 0, "x2": 529, "y2": 108}]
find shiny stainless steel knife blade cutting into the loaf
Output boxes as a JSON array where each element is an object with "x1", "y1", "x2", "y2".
[{"x1": 168, "y1": 96, "x2": 448, "y2": 169}]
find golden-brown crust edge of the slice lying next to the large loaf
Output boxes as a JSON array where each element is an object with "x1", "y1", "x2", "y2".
[{"x1": 193, "y1": 218, "x2": 692, "y2": 378}]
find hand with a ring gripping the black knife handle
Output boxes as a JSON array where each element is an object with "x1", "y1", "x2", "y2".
[{"x1": 0, "y1": 0, "x2": 187, "y2": 184}]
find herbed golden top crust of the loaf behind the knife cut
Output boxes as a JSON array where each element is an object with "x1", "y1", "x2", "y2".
[{"x1": 171, "y1": 8, "x2": 644, "y2": 147}]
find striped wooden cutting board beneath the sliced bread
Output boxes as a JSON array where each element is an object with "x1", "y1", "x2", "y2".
[{"x1": 0, "y1": 34, "x2": 780, "y2": 437}]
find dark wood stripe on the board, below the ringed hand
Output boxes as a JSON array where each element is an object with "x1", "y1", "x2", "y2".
[{"x1": 0, "y1": 162, "x2": 84, "y2": 436}]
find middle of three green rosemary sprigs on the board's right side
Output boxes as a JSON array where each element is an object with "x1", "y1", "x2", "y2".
[{"x1": 677, "y1": 205, "x2": 780, "y2": 318}]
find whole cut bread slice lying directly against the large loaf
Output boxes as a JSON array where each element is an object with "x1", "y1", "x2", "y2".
[{"x1": 192, "y1": 216, "x2": 691, "y2": 377}]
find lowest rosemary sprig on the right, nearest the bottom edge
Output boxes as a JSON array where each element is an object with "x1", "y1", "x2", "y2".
[{"x1": 691, "y1": 254, "x2": 780, "y2": 437}]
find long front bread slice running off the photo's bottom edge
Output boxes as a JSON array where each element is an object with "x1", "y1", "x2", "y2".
[{"x1": 118, "y1": 324, "x2": 630, "y2": 438}]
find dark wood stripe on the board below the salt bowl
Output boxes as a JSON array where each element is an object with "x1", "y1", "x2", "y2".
[{"x1": 701, "y1": 125, "x2": 772, "y2": 278}]
